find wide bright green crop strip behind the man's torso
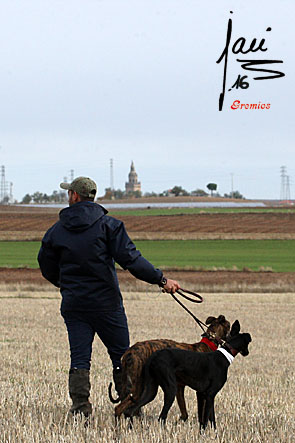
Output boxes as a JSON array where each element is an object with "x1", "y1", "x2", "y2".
[{"x1": 0, "y1": 240, "x2": 295, "y2": 272}]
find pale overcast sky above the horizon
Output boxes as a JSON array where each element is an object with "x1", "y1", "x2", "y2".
[{"x1": 0, "y1": 0, "x2": 295, "y2": 199}]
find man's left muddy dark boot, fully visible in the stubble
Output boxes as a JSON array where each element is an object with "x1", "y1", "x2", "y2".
[{"x1": 69, "y1": 368, "x2": 92, "y2": 417}]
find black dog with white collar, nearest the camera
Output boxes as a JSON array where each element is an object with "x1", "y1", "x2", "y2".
[{"x1": 130, "y1": 320, "x2": 251, "y2": 430}]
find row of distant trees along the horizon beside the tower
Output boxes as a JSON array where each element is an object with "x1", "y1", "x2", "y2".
[{"x1": 21, "y1": 183, "x2": 244, "y2": 204}]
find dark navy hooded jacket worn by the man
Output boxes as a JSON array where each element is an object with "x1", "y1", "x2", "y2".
[{"x1": 38, "y1": 201, "x2": 163, "y2": 313}]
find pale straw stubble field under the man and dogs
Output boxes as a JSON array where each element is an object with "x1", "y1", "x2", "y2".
[{"x1": 0, "y1": 287, "x2": 295, "y2": 443}]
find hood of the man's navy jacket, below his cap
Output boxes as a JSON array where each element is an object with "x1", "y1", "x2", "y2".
[{"x1": 59, "y1": 201, "x2": 108, "y2": 232}]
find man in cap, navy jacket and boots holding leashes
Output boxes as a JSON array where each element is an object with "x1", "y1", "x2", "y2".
[{"x1": 38, "y1": 177, "x2": 179, "y2": 416}]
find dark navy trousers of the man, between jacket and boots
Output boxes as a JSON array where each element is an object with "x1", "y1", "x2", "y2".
[{"x1": 62, "y1": 307, "x2": 129, "y2": 369}]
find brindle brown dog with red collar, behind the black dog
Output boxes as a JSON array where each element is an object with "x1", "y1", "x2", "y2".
[{"x1": 109, "y1": 315, "x2": 230, "y2": 421}]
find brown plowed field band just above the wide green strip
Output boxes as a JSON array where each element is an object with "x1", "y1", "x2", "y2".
[{"x1": 0, "y1": 207, "x2": 295, "y2": 240}]
